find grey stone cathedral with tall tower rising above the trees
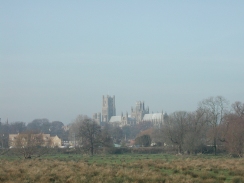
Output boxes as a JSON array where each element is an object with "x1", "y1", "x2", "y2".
[{"x1": 93, "y1": 95, "x2": 166, "y2": 128}]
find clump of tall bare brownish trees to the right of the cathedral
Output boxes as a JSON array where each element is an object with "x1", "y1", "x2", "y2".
[{"x1": 151, "y1": 96, "x2": 244, "y2": 157}]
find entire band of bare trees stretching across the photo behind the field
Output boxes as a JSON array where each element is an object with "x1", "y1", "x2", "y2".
[{"x1": 0, "y1": 96, "x2": 244, "y2": 157}]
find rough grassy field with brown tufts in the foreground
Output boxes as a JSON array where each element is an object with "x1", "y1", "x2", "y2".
[{"x1": 0, "y1": 154, "x2": 244, "y2": 183}]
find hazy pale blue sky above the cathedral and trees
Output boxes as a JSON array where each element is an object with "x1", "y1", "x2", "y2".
[{"x1": 0, "y1": 0, "x2": 244, "y2": 124}]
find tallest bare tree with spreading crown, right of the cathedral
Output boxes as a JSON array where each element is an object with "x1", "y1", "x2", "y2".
[{"x1": 199, "y1": 96, "x2": 228, "y2": 155}]
